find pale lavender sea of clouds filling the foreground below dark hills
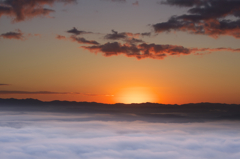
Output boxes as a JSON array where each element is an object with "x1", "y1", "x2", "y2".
[{"x1": 0, "y1": 111, "x2": 240, "y2": 159}]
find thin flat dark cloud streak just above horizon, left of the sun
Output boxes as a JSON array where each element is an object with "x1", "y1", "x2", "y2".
[{"x1": 0, "y1": 90, "x2": 112, "y2": 96}]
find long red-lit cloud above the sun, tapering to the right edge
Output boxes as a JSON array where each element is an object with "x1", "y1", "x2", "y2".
[{"x1": 81, "y1": 42, "x2": 240, "y2": 60}]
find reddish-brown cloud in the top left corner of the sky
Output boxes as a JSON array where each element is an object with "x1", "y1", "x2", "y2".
[{"x1": 0, "y1": 0, "x2": 75, "y2": 22}]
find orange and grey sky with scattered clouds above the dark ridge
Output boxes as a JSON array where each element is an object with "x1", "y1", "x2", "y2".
[{"x1": 0, "y1": 0, "x2": 240, "y2": 104}]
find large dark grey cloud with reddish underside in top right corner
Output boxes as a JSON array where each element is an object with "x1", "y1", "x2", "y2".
[{"x1": 152, "y1": 0, "x2": 240, "y2": 38}]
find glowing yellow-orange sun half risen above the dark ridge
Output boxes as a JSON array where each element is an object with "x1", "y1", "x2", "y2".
[{"x1": 117, "y1": 87, "x2": 156, "y2": 104}]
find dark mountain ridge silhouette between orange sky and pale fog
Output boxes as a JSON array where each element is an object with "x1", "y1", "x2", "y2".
[{"x1": 0, "y1": 98, "x2": 240, "y2": 122}]
